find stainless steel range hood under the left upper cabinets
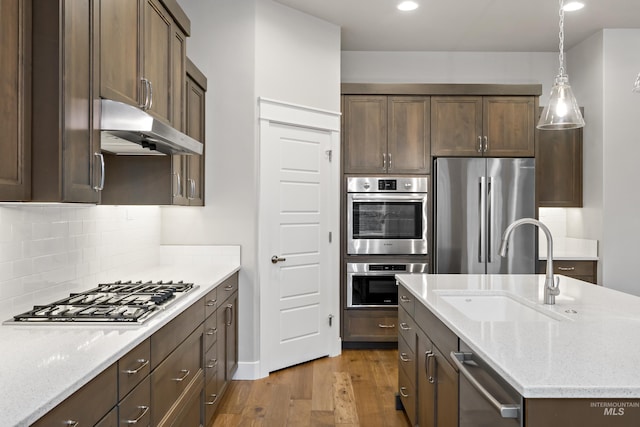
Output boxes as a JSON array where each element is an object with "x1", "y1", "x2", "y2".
[{"x1": 100, "y1": 99, "x2": 203, "y2": 155}]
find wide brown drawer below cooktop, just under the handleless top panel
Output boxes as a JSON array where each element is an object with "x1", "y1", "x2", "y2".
[{"x1": 151, "y1": 324, "x2": 204, "y2": 425}]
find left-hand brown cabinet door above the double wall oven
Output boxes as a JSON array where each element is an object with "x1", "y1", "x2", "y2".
[{"x1": 343, "y1": 95, "x2": 387, "y2": 173}]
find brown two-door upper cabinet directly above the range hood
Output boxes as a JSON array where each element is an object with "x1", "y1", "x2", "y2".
[{"x1": 95, "y1": 0, "x2": 190, "y2": 130}]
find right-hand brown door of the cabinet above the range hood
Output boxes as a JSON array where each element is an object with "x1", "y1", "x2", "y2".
[{"x1": 142, "y1": 0, "x2": 174, "y2": 123}]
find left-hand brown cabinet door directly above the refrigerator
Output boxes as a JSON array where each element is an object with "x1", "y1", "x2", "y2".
[{"x1": 431, "y1": 96, "x2": 483, "y2": 157}]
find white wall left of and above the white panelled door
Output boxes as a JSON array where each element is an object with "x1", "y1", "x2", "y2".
[{"x1": 168, "y1": 0, "x2": 340, "y2": 374}]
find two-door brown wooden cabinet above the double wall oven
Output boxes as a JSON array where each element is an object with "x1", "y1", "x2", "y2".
[{"x1": 342, "y1": 95, "x2": 431, "y2": 174}]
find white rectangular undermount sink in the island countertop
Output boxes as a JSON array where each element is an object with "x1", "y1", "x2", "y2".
[{"x1": 440, "y1": 294, "x2": 566, "y2": 322}]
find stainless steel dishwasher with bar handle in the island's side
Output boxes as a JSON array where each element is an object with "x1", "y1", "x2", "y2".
[{"x1": 451, "y1": 340, "x2": 523, "y2": 427}]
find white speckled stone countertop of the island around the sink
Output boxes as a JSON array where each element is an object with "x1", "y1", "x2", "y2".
[{"x1": 396, "y1": 274, "x2": 640, "y2": 398}]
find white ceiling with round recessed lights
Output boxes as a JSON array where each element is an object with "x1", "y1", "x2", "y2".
[{"x1": 275, "y1": 0, "x2": 640, "y2": 52}]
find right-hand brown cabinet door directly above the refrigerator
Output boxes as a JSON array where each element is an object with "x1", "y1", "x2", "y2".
[{"x1": 483, "y1": 96, "x2": 536, "y2": 157}]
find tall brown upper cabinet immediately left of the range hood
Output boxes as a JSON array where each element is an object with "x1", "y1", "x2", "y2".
[{"x1": 31, "y1": 0, "x2": 104, "y2": 203}]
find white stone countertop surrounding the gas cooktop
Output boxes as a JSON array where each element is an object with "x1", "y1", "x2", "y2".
[{"x1": 0, "y1": 247, "x2": 240, "y2": 426}]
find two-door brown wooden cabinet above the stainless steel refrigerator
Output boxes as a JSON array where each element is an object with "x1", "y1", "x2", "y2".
[{"x1": 431, "y1": 96, "x2": 537, "y2": 157}]
